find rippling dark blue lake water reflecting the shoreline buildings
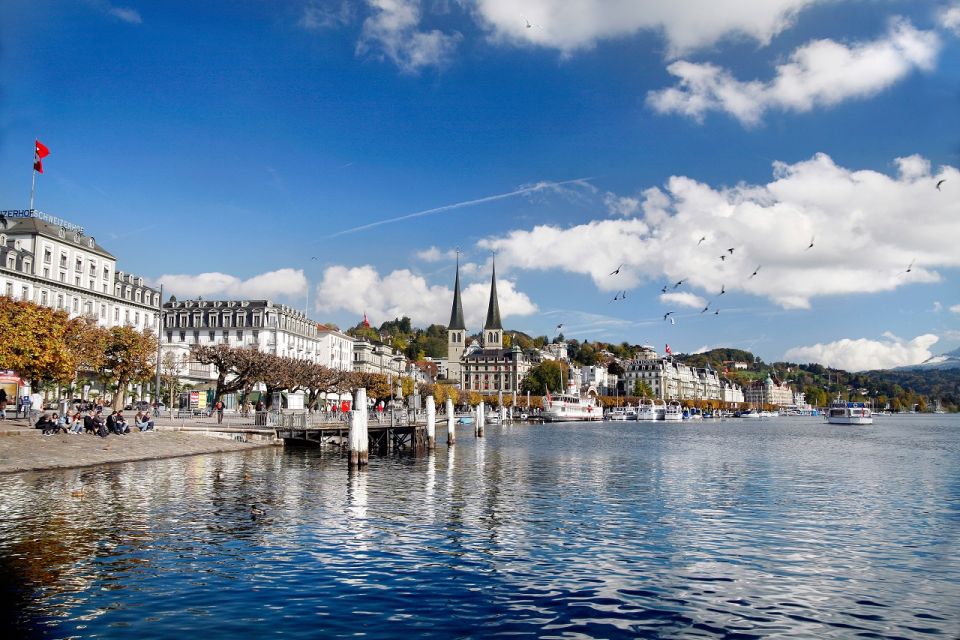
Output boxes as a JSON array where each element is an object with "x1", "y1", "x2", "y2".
[{"x1": 0, "y1": 415, "x2": 960, "y2": 639}]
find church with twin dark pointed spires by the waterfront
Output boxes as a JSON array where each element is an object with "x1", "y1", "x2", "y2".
[{"x1": 447, "y1": 259, "x2": 532, "y2": 395}]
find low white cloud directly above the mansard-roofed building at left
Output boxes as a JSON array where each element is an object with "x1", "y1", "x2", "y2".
[{"x1": 157, "y1": 268, "x2": 307, "y2": 299}]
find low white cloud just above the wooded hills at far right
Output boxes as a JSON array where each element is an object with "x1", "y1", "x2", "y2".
[{"x1": 784, "y1": 333, "x2": 939, "y2": 371}]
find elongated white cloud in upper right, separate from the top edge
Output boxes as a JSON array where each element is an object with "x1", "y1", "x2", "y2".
[{"x1": 647, "y1": 18, "x2": 940, "y2": 125}]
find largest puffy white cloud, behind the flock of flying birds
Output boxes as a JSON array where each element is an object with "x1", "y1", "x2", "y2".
[{"x1": 478, "y1": 154, "x2": 960, "y2": 308}]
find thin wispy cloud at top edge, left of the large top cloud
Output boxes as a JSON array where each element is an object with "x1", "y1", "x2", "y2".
[{"x1": 357, "y1": 0, "x2": 461, "y2": 73}]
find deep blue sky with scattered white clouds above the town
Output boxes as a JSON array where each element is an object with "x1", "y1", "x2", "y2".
[{"x1": 0, "y1": 0, "x2": 960, "y2": 369}]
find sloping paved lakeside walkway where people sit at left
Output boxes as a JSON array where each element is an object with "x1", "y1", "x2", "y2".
[{"x1": 0, "y1": 418, "x2": 273, "y2": 473}]
